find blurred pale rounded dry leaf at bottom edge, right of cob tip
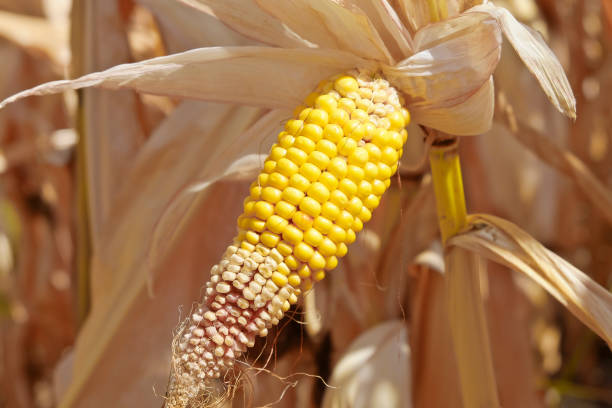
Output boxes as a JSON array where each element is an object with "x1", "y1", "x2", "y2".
[{"x1": 322, "y1": 320, "x2": 412, "y2": 408}]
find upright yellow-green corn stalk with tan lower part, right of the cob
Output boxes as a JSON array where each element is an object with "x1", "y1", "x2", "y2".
[{"x1": 429, "y1": 138, "x2": 500, "y2": 408}]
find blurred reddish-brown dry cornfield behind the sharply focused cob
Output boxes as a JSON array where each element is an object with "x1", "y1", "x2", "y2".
[{"x1": 0, "y1": 0, "x2": 612, "y2": 408}]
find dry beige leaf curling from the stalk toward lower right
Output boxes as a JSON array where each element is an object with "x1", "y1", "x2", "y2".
[{"x1": 448, "y1": 214, "x2": 612, "y2": 348}]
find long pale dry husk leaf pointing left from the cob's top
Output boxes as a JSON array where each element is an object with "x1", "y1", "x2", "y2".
[{"x1": 0, "y1": 47, "x2": 371, "y2": 109}]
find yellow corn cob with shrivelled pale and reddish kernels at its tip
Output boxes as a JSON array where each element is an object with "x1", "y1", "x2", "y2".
[{"x1": 169, "y1": 73, "x2": 409, "y2": 406}]
